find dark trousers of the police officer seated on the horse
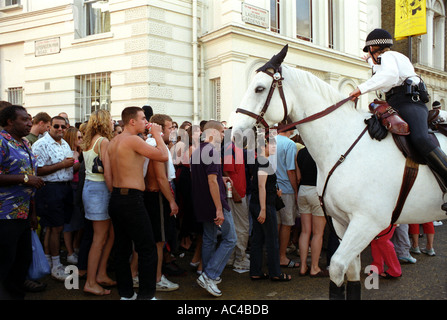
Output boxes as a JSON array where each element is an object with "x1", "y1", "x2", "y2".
[{"x1": 387, "y1": 93, "x2": 437, "y2": 157}]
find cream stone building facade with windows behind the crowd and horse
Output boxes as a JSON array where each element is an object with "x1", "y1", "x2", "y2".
[{"x1": 0, "y1": 0, "x2": 447, "y2": 123}]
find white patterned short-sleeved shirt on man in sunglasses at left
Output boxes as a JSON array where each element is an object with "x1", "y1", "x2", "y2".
[{"x1": 31, "y1": 133, "x2": 73, "y2": 182}]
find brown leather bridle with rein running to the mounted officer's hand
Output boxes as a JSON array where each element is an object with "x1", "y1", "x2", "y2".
[{"x1": 236, "y1": 67, "x2": 358, "y2": 132}]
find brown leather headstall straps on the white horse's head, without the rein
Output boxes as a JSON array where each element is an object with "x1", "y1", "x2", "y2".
[{"x1": 236, "y1": 67, "x2": 288, "y2": 129}]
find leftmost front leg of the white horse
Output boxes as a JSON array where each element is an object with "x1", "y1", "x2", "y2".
[{"x1": 329, "y1": 213, "x2": 386, "y2": 298}]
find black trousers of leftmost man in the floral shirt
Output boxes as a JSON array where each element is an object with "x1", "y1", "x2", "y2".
[{"x1": 0, "y1": 219, "x2": 33, "y2": 300}]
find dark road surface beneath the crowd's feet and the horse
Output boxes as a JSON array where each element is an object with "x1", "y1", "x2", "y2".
[{"x1": 26, "y1": 220, "x2": 447, "y2": 303}]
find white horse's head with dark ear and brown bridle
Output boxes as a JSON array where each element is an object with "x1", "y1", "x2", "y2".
[{"x1": 232, "y1": 45, "x2": 288, "y2": 130}]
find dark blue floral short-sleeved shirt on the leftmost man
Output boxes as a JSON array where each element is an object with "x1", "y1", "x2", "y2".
[{"x1": 0, "y1": 130, "x2": 36, "y2": 219}]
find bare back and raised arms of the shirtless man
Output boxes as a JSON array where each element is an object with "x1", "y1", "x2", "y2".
[{"x1": 105, "y1": 112, "x2": 168, "y2": 191}]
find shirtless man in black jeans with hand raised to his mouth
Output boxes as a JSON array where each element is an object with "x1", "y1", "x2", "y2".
[{"x1": 104, "y1": 107, "x2": 168, "y2": 300}]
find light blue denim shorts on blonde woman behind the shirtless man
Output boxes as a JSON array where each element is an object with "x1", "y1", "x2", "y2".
[{"x1": 82, "y1": 180, "x2": 110, "y2": 221}]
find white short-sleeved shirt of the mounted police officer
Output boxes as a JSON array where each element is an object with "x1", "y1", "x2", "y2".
[{"x1": 358, "y1": 51, "x2": 420, "y2": 94}]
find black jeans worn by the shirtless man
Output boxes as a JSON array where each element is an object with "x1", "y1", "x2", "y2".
[{"x1": 109, "y1": 188, "x2": 158, "y2": 299}]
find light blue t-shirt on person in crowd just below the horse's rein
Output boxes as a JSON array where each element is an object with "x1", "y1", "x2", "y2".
[{"x1": 269, "y1": 135, "x2": 297, "y2": 194}]
